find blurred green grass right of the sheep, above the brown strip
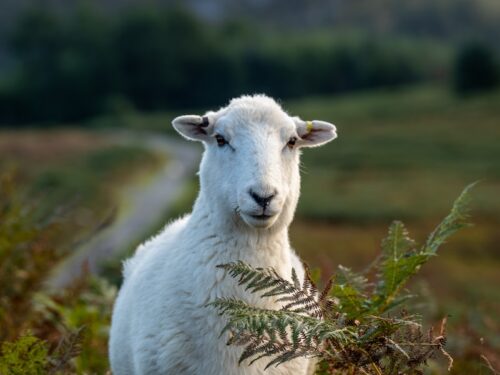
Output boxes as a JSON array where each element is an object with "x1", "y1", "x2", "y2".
[{"x1": 286, "y1": 88, "x2": 500, "y2": 222}]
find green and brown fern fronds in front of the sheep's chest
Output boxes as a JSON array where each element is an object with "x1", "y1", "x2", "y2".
[{"x1": 211, "y1": 185, "x2": 473, "y2": 375}]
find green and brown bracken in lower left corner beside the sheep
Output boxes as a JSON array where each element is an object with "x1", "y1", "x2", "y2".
[{"x1": 0, "y1": 177, "x2": 116, "y2": 375}]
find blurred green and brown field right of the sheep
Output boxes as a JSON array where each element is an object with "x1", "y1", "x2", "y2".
[{"x1": 286, "y1": 87, "x2": 500, "y2": 374}]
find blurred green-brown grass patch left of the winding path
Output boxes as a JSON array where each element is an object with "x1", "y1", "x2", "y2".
[{"x1": 0, "y1": 128, "x2": 164, "y2": 250}]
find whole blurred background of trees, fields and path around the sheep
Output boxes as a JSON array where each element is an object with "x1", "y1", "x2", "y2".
[{"x1": 0, "y1": 0, "x2": 500, "y2": 374}]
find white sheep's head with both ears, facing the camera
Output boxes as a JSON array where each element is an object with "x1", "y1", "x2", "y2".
[{"x1": 173, "y1": 95, "x2": 336, "y2": 228}]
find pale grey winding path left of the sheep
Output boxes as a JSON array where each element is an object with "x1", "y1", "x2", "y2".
[{"x1": 47, "y1": 133, "x2": 200, "y2": 290}]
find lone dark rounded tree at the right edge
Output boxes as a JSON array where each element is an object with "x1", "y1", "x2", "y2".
[{"x1": 453, "y1": 43, "x2": 500, "y2": 94}]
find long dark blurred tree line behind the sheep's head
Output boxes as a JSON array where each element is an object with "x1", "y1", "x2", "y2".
[{"x1": 0, "y1": 6, "x2": 441, "y2": 123}]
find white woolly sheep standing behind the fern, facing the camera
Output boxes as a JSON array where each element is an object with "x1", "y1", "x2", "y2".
[{"x1": 109, "y1": 95, "x2": 336, "y2": 375}]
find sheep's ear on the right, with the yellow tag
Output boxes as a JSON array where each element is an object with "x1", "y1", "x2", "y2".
[{"x1": 293, "y1": 117, "x2": 337, "y2": 147}]
